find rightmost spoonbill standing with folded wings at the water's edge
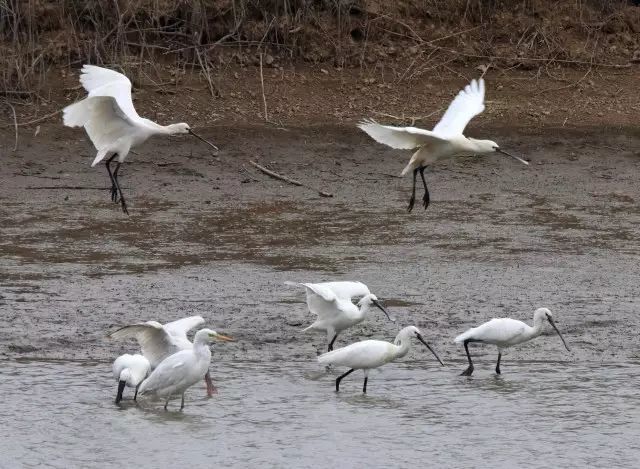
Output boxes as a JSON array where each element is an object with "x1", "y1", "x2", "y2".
[{"x1": 454, "y1": 308, "x2": 569, "y2": 376}]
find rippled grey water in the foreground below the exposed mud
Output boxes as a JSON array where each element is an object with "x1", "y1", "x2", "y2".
[{"x1": 0, "y1": 361, "x2": 640, "y2": 468}]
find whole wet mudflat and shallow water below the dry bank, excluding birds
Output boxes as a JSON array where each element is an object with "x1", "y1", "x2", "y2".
[{"x1": 0, "y1": 128, "x2": 640, "y2": 467}]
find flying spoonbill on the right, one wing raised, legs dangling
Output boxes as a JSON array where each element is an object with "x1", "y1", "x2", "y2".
[{"x1": 358, "y1": 78, "x2": 529, "y2": 211}]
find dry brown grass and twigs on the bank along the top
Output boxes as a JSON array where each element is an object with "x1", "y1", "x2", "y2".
[{"x1": 0, "y1": 0, "x2": 640, "y2": 94}]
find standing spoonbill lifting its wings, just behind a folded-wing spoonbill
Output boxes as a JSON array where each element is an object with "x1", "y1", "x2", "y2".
[{"x1": 286, "y1": 282, "x2": 395, "y2": 352}]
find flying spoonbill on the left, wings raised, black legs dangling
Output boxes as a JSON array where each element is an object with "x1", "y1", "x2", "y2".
[{"x1": 62, "y1": 65, "x2": 217, "y2": 214}]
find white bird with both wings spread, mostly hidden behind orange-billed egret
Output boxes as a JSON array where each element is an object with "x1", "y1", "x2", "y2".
[{"x1": 109, "y1": 316, "x2": 216, "y2": 397}]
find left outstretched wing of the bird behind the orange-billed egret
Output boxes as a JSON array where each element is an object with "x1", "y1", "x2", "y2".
[{"x1": 109, "y1": 321, "x2": 179, "y2": 368}]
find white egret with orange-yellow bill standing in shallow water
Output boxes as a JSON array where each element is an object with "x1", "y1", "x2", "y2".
[{"x1": 140, "y1": 329, "x2": 233, "y2": 410}]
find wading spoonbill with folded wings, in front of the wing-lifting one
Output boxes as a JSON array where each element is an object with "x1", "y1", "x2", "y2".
[{"x1": 318, "y1": 326, "x2": 444, "y2": 393}]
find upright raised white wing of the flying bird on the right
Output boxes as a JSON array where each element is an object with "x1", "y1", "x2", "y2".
[{"x1": 433, "y1": 78, "x2": 484, "y2": 138}]
